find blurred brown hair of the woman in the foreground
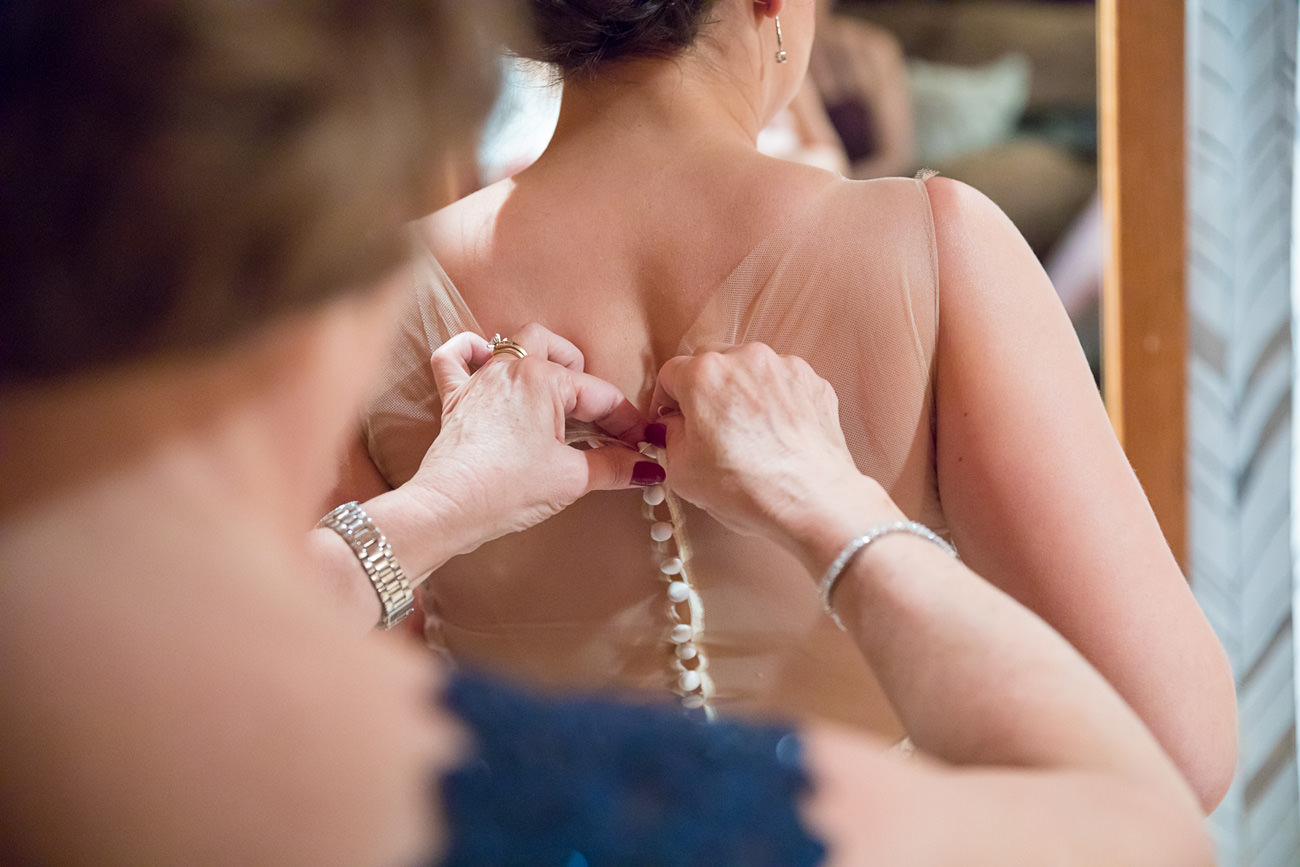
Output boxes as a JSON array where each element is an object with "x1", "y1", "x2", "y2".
[{"x1": 0, "y1": 0, "x2": 497, "y2": 383}]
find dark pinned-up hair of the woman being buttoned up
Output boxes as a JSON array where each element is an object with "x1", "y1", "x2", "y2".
[{"x1": 519, "y1": 0, "x2": 718, "y2": 78}]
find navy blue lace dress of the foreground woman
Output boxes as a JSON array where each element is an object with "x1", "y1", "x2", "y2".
[{"x1": 441, "y1": 675, "x2": 826, "y2": 867}]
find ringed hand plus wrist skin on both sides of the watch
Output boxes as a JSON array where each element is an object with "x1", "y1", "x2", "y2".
[{"x1": 308, "y1": 325, "x2": 664, "y2": 628}]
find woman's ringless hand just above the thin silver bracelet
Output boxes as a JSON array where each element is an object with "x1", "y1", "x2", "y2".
[{"x1": 651, "y1": 343, "x2": 902, "y2": 572}]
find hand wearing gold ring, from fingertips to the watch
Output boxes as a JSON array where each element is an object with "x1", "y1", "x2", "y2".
[{"x1": 404, "y1": 325, "x2": 663, "y2": 550}]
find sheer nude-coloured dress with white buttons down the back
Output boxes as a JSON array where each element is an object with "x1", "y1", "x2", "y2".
[{"x1": 364, "y1": 179, "x2": 946, "y2": 736}]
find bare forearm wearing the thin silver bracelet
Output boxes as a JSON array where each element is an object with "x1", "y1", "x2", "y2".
[{"x1": 792, "y1": 486, "x2": 1191, "y2": 799}]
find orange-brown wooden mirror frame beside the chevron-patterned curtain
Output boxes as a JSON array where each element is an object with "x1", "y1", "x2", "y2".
[{"x1": 1097, "y1": 0, "x2": 1188, "y2": 572}]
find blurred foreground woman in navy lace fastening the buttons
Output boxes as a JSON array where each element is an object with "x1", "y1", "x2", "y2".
[{"x1": 0, "y1": 0, "x2": 1208, "y2": 864}]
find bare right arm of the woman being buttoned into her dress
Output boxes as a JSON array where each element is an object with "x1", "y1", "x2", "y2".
[{"x1": 928, "y1": 179, "x2": 1235, "y2": 805}]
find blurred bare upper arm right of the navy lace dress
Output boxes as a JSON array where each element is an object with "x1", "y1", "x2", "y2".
[{"x1": 803, "y1": 725, "x2": 1214, "y2": 867}]
